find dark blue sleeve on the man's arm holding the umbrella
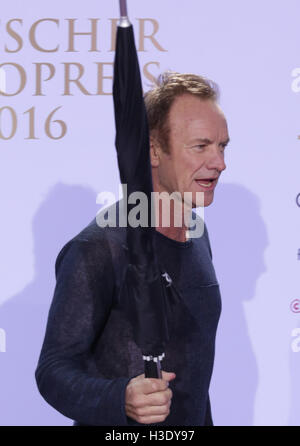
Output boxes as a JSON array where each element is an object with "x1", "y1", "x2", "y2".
[{"x1": 35, "y1": 239, "x2": 130, "y2": 426}]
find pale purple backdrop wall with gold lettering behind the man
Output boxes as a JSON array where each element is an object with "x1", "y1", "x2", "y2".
[{"x1": 0, "y1": 0, "x2": 300, "y2": 425}]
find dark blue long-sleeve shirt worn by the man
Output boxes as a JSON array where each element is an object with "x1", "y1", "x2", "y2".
[{"x1": 35, "y1": 203, "x2": 221, "y2": 426}]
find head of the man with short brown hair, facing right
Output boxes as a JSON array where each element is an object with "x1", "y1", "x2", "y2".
[{"x1": 145, "y1": 72, "x2": 229, "y2": 207}]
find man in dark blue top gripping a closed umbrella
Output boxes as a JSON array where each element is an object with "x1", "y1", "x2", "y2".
[{"x1": 35, "y1": 73, "x2": 229, "y2": 426}]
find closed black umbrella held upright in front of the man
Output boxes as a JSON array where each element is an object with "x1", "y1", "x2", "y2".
[{"x1": 113, "y1": 0, "x2": 179, "y2": 378}]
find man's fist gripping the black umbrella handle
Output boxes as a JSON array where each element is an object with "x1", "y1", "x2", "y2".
[{"x1": 125, "y1": 371, "x2": 176, "y2": 424}]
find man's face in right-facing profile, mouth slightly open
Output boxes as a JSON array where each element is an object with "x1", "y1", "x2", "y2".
[{"x1": 152, "y1": 94, "x2": 229, "y2": 207}]
